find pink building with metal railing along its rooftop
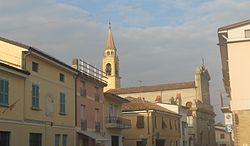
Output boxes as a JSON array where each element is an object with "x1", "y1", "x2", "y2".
[{"x1": 73, "y1": 59, "x2": 107, "y2": 146}]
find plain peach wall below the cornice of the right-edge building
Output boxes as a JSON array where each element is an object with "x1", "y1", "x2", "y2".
[{"x1": 228, "y1": 41, "x2": 250, "y2": 110}]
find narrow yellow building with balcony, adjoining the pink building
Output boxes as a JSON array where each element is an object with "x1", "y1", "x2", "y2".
[{"x1": 104, "y1": 93, "x2": 131, "y2": 146}]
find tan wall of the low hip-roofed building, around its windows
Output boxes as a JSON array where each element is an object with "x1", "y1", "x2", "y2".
[{"x1": 122, "y1": 110, "x2": 180, "y2": 146}]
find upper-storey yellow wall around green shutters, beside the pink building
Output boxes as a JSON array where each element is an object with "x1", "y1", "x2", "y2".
[{"x1": 25, "y1": 55, "x2": 75, "y2": 126}]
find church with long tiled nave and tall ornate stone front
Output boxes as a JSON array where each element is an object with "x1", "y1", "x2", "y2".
[{"x1": 107, "y1": 66, "x2": 216, "y2": 146}]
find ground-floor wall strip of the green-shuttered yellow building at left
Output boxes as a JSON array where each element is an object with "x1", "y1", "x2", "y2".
[{"x1": 0, "y1": 121, "x2": 74, "y2": 146}]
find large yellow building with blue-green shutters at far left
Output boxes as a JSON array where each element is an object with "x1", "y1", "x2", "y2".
[{"x1": 0, "y1": 38, "x2": 77, "y2": 146}]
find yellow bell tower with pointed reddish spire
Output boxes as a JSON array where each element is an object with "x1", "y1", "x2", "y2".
[{"x1": 102, "y1": 22, "x2": 121, "y2": 91}]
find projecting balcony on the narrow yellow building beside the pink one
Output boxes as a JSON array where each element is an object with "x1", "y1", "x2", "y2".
[{"x1": 106, "y1": 116, "x2": 131, "y2": 129}]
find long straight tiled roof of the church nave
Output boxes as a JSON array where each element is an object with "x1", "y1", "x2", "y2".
[{"x1": 107, "y1": 81, "x2": 195, "y2": 94}]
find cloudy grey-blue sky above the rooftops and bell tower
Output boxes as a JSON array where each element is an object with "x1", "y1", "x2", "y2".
[{"x1": 0, "y1": 0, "x2": 250, "y2": 122}]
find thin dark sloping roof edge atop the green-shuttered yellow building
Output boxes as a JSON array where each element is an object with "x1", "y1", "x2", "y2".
[{"x1": 0, "y1": 37, "x2": 77, "y2": 72}]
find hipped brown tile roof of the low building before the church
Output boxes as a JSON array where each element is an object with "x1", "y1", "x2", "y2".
[{"x1": 122, "y1": 97, "x2": 178, "y2": 115}]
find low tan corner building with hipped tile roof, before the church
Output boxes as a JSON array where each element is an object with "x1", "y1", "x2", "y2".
[{"x1": 122, "y1": 97, "x2": 181, "y2": 146}]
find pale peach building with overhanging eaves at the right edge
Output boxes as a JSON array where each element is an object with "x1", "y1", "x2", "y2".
[{"x1": 218, "y1": 20, "x2": 250, "y2": 146}]
